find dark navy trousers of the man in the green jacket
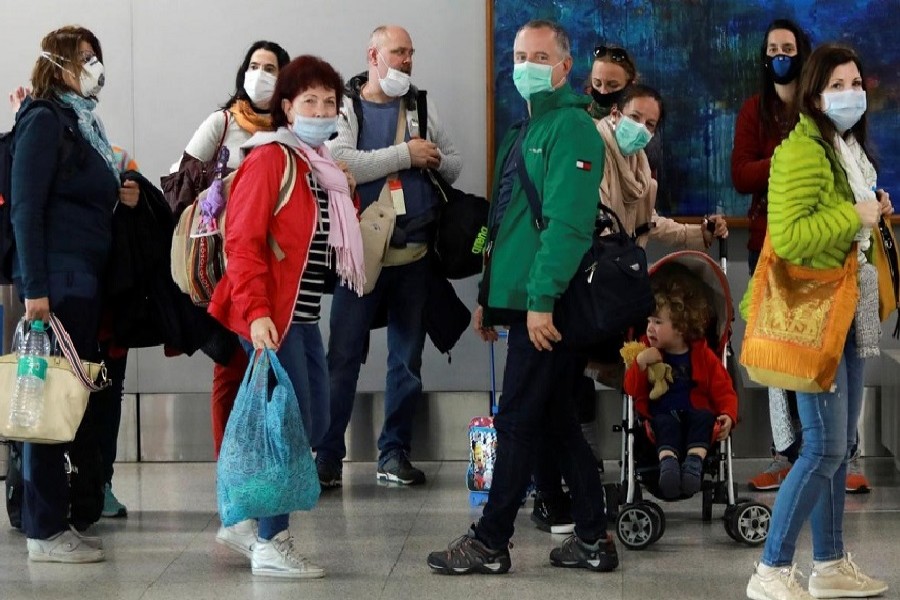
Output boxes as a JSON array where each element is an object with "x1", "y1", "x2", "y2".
[{"x1": 475, "y1": 323, "x2": 606, "y2": 549}]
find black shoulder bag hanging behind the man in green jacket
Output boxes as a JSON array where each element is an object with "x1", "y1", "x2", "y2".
[{"x1": 553, "y1": 204, "x2": 654, "y2": 354}]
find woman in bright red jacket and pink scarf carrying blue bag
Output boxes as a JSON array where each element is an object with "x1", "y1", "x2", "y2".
[{"x1": 209, "y1": 56, "x2": 365, "y2": 578}]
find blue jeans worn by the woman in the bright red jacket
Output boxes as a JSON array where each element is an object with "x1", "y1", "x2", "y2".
[{"x1": 241, "y1": 323, "x2": 329, "y2": 540}]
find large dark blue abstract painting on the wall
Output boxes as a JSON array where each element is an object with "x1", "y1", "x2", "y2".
[{"x1": 492, "y1": 0, "x2": 900, "y2": 216}]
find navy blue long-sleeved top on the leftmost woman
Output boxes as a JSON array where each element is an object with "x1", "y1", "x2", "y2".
[{"x1": 10, "y1": 98, "x2": 119, "y2": 298}]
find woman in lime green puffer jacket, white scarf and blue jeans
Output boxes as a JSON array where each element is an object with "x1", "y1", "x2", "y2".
[{"x1": 747, "y1": 45, "x2": 892, "y2": 600}]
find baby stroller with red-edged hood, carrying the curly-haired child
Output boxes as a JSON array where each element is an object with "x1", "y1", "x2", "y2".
[{"x1": 604, "y1": 246, "x2": 772, "y2": 550}]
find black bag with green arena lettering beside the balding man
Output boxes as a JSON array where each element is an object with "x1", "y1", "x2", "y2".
[{"x1": 428, "y1": 170, "x2": 490, "y2": 279}]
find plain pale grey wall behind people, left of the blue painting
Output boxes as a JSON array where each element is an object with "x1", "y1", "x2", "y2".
[{"x1": 0, "y1": 0, "x2": 487, "y2": 391}]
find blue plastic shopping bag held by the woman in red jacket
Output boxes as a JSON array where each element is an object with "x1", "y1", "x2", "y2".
[{"x1": 216, "y1": 350, "x2": 321, "y2": 527}]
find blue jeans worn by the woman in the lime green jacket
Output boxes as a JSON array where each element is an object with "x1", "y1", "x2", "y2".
[{"x1": 762, "y1": 327, "x2": 865, "y2": 567}]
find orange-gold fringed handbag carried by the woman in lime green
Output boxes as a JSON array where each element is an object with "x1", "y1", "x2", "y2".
[{"x1": 740, "y1": 235, "x2": 859, "y2": 393}]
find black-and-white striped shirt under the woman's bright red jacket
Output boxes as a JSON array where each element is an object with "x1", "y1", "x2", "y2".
[{"x1": 291, "y1": 171, "x2": 331, "y2": 323}]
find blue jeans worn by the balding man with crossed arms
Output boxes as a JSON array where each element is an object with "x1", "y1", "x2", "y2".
[{"x1": 316, "y1": 258, "x2": 429, "y2": 466}]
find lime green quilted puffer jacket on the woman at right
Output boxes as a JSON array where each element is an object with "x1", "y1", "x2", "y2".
[{"x1": 741, "y1": 114, "x2": 861, "y2": 319}]
